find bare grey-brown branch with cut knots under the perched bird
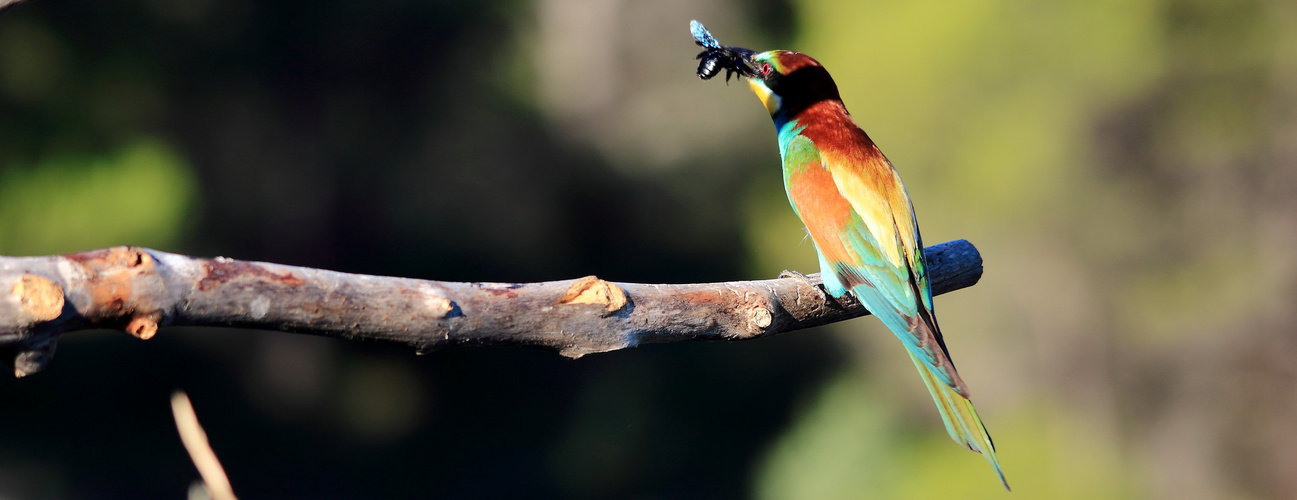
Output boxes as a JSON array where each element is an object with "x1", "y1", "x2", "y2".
[{"x1": 0, "y1": 240, "x2": 982, "y2": 377}]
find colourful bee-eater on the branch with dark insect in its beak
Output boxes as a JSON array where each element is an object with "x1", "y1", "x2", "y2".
[{"x1": 690, "y1": 21, "x2": 1012, "y2": 491}]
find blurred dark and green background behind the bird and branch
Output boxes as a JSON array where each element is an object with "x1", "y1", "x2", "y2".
[{"x1": 0, "y1": 0, "x2": 1297, "y2": 500}]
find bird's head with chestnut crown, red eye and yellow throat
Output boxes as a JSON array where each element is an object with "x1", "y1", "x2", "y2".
[{"x1": 744, "y1": 51, "x2": 842, "y2": 120}]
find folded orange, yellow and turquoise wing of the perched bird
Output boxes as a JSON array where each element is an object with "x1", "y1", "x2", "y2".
[{"x1": 785, "y1": 137, "x2": 968, "y2": 394}]
